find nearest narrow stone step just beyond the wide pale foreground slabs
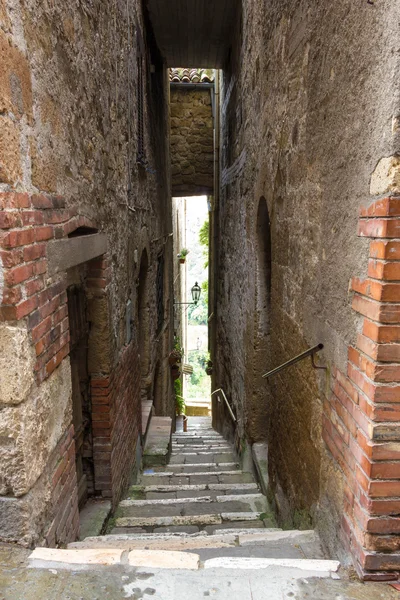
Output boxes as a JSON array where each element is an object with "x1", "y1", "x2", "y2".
[{"x1": 115, "y1": 507, "x2": 263, "y2": 529}]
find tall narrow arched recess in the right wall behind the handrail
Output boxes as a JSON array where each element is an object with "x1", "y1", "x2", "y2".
[{"x1": 247, "y1": 196, "x2": 272, "y2": 441}]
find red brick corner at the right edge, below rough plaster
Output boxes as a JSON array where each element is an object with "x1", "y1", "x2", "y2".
[{"x1": 323, "y1": 197, "x2": 400, "y2": 579}]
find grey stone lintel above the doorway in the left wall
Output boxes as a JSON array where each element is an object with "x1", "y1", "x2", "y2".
[{"x1": 47, "y1": 233, "x2": 107, "y2": 275}]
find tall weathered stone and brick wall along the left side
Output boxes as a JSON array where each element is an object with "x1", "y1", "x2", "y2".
[{"x1": 0, "y1": 0, "x2": 173, "y2": 545}]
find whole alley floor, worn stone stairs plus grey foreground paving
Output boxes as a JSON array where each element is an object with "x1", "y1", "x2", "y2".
[{"x1": 0, "y1": 417, "x2": 397, "y2": 600}]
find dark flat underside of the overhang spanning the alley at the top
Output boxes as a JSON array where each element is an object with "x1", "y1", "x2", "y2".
[{"x1": 146, "y1": 0, "x2": 240, "y2": 69}]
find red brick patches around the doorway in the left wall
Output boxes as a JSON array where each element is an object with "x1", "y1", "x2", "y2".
[{"x1": 0, "y1": 192, "x2": 141, "y2": 545}]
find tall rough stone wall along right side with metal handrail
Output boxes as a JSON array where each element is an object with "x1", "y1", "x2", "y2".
[{"x1": 213, "y1": 0, "x2": 400, "y2": 577}]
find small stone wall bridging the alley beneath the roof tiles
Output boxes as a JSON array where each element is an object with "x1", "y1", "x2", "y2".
[{"x1": 170, "y1": 84, "x2": 214, "y2": 197}]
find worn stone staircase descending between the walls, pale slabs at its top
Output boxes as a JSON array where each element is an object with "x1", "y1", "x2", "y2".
[{"x1": 30, "y1": 418, "x2": 340, "y2": 600}]
